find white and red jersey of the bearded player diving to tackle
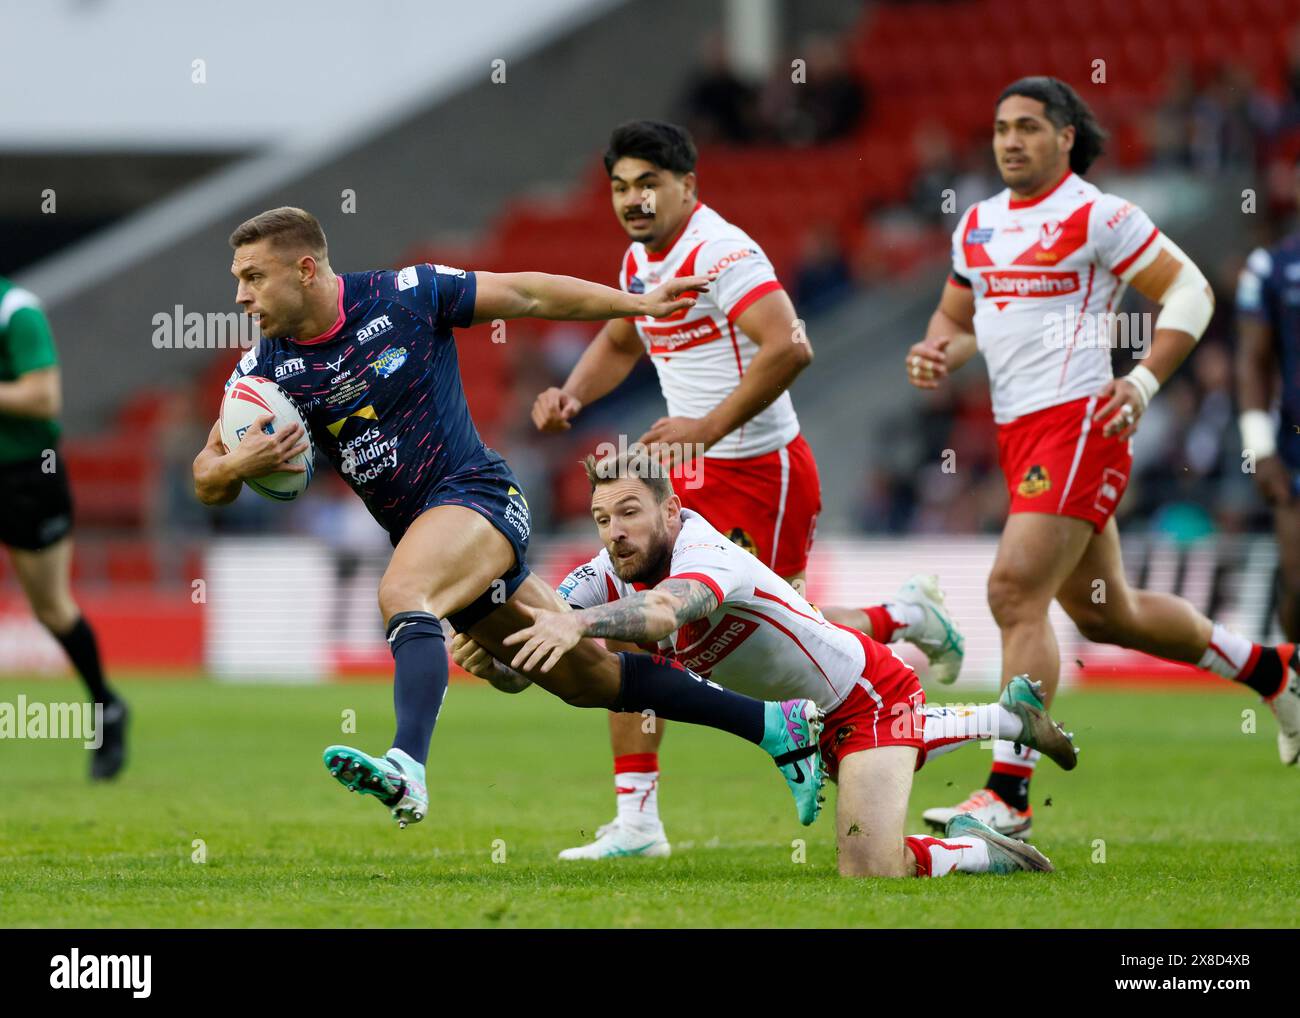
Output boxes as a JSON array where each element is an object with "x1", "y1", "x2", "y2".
[{"x1": 559, "y1": 510, "x2": 899, "y2": 711}]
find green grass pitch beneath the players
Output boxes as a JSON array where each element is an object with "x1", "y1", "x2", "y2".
[{"x1": 0, "y1": 680, "x2": 1300, "y2": 927}]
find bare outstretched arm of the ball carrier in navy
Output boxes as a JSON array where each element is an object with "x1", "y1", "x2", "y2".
[{"x1": 475, "y1": 272, "x2": 710, "y2": 322}]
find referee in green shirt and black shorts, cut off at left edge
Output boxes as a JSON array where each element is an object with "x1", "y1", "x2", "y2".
[{"x1": 0, "y1": 278, "x2": 126, "y2": 779}]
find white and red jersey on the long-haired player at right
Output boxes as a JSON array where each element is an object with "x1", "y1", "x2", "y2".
[{"x1": 953, "y1": 173, "x2": 1158, "y2": 424}]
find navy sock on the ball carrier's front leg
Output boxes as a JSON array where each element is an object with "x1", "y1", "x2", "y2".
[{"x1": 389, "y1": 611, "x2": 447, "y2": 764}]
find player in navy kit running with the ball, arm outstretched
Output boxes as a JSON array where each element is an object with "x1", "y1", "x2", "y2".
[{"x1": 194, "y1": 208, "x2": 822, "y2": 827}]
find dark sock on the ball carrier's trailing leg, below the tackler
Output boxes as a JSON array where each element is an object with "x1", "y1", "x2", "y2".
[{"x1": 612, "y1": 653, "x2": 766, "y2": 745}]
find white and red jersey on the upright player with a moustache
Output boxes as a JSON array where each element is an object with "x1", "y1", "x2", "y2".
[{"x1": 619, "y1": 203, "x2": 800, "y2": 459}]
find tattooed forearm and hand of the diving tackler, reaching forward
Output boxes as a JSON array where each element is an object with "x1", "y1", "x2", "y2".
[{"x1": 504, "y1": 579, "x2": 718, "y2": 672}]
